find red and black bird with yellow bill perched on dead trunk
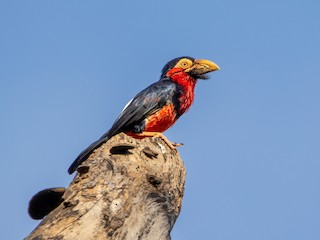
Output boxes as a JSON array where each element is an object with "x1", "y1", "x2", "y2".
[{"x1": 68, "y1": 56, "x2": 220, "y2": 174}]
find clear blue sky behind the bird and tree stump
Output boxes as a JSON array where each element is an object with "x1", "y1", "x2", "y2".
[{"x1": 0, "y1": 0, "x2": 320, "y2": 240}]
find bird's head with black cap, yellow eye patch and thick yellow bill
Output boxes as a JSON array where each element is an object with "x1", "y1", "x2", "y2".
[{"x1": 161, "y1": 57, "x2": 220, "y2": 80}]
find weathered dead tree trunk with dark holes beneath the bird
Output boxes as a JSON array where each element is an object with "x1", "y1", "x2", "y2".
[{"x1": 25, "y1": 134, "x2": 185, "y2": 240}]
